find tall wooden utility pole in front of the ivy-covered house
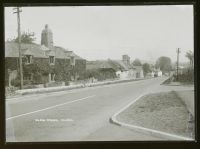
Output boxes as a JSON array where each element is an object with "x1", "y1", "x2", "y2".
[{"x1": 13, "y1": 7, "x2": 23, "y2": 89}]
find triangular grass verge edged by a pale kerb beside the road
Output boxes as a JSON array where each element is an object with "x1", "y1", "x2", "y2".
[{"x1": 117, "y1": 91, "x2": 194, "y2": 137}]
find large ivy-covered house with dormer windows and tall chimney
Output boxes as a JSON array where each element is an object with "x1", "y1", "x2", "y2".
[{"x1": 5, "y1": 25, "x2": 86, "y2": 86}]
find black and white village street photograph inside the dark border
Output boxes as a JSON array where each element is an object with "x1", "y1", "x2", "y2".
[{"x1": 4, "y1": 4, "x2": 196, "y2": 142}]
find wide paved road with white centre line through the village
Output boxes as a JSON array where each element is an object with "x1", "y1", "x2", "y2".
[{"x1": 6, "y1": 77, "x2": 192, "y2": 142}]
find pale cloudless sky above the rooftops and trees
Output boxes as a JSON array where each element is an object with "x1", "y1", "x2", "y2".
[{"x1": 5, "y1": 5, "x2": 194, "y2": 62}]
